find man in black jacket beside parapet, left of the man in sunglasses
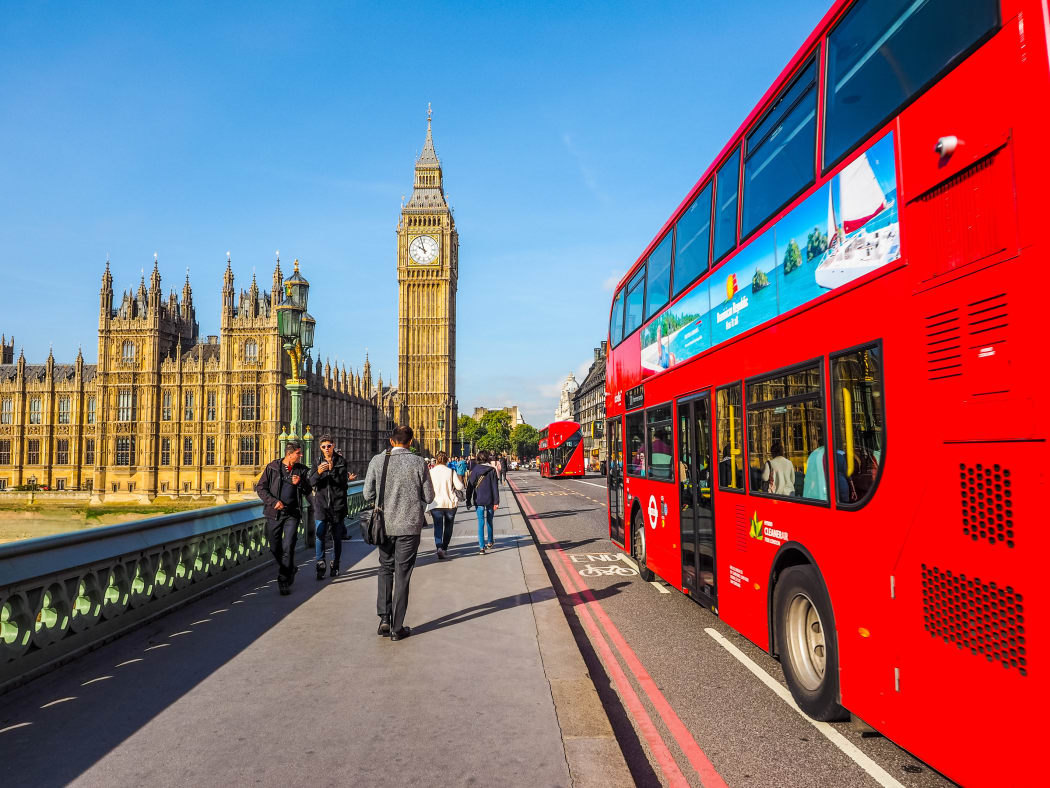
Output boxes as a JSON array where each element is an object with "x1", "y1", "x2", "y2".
[{"x1": 255, "y1": 440, "x2": 310, "y2": 596}]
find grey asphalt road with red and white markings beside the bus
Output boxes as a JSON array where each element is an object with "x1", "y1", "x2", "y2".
[{"x1": 510, "y1": 472, "x2": 953, "y2": 788}]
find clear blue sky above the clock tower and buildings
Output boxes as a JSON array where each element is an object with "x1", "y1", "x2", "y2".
[{"x1": 0, "y1": 0, "x2": 830, "y2": 424}]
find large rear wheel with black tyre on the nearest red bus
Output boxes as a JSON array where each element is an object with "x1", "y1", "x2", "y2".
[{"x1": 773, "y1": 564, "x2": 849, "y2": 722}]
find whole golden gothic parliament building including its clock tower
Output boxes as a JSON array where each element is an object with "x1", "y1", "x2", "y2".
[{"x1": 0, "y1": 112, "x2": 458, "y2": 502}]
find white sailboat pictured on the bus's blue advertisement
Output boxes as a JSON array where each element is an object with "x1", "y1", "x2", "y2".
[{"x1": 816, "y1": 153, "x2": 901, "y2": 290}]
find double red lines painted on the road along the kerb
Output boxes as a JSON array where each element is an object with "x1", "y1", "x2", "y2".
[{"x1": 511, "y1": 482, "x2": 728, "y2": 788}]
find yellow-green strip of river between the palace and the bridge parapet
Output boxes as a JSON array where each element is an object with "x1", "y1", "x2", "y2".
[{"x1": 0, "y1": 498, "x2": 216, "y2": 544}]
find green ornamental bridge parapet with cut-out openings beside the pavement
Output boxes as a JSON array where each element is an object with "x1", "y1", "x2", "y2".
[{"x1": 0, "y1": 481, "x2": 368, "y2": 692}]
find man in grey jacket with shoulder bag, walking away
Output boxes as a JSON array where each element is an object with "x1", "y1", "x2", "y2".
[{"x1": 364, "y1": 424, "x2": 434, "y2": 640}]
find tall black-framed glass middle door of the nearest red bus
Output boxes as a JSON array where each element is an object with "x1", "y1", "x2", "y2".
[{"x1": 677, "y1": 393, "x2": 717, "y2": 607}]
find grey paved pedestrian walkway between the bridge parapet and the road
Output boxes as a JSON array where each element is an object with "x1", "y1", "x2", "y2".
[{"x1": 0, "y1": 488, "x2": 618, "y2": 787}]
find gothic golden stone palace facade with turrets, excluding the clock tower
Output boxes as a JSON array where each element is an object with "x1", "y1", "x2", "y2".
[{"x1": 0, "y1": 258, "x2": 397, "y2": 501}]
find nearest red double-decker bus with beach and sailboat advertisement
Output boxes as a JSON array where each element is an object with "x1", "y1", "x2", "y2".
[{"x1": 606, "y1": 0, "x2": 1037, "y2": 785}]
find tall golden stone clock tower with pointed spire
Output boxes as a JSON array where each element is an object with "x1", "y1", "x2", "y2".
[{"x1": 397, "y1": 107, "x2": 459, "y2": 456}]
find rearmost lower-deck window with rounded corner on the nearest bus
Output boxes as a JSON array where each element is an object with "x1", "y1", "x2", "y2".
[{"x1": 832, "y1": 346, "x2": 886, "y2": 507}]
